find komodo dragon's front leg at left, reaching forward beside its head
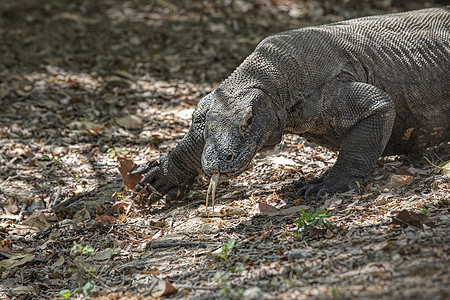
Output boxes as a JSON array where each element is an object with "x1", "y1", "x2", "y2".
[{"x1": 130, "y1": 94, "x2": 212, "y2": 199}]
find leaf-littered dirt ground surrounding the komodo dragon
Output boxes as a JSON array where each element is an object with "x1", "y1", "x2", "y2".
[{"x1": 0, "y1": 0, "x2": 450, "y2": 299}]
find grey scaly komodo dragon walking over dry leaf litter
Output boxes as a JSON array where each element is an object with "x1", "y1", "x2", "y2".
[{"x1": 131, "y1": 6, "x2": 450, "y2": 199}]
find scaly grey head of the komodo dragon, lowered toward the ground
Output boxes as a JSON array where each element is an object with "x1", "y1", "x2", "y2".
[{"x1": 202, "y1": 88, "x2": 279, "y2": 179}]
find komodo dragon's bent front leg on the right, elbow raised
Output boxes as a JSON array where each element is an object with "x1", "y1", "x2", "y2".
[{"x1": 297, "y1": 82, "x2": 395, "y2": 199}]
